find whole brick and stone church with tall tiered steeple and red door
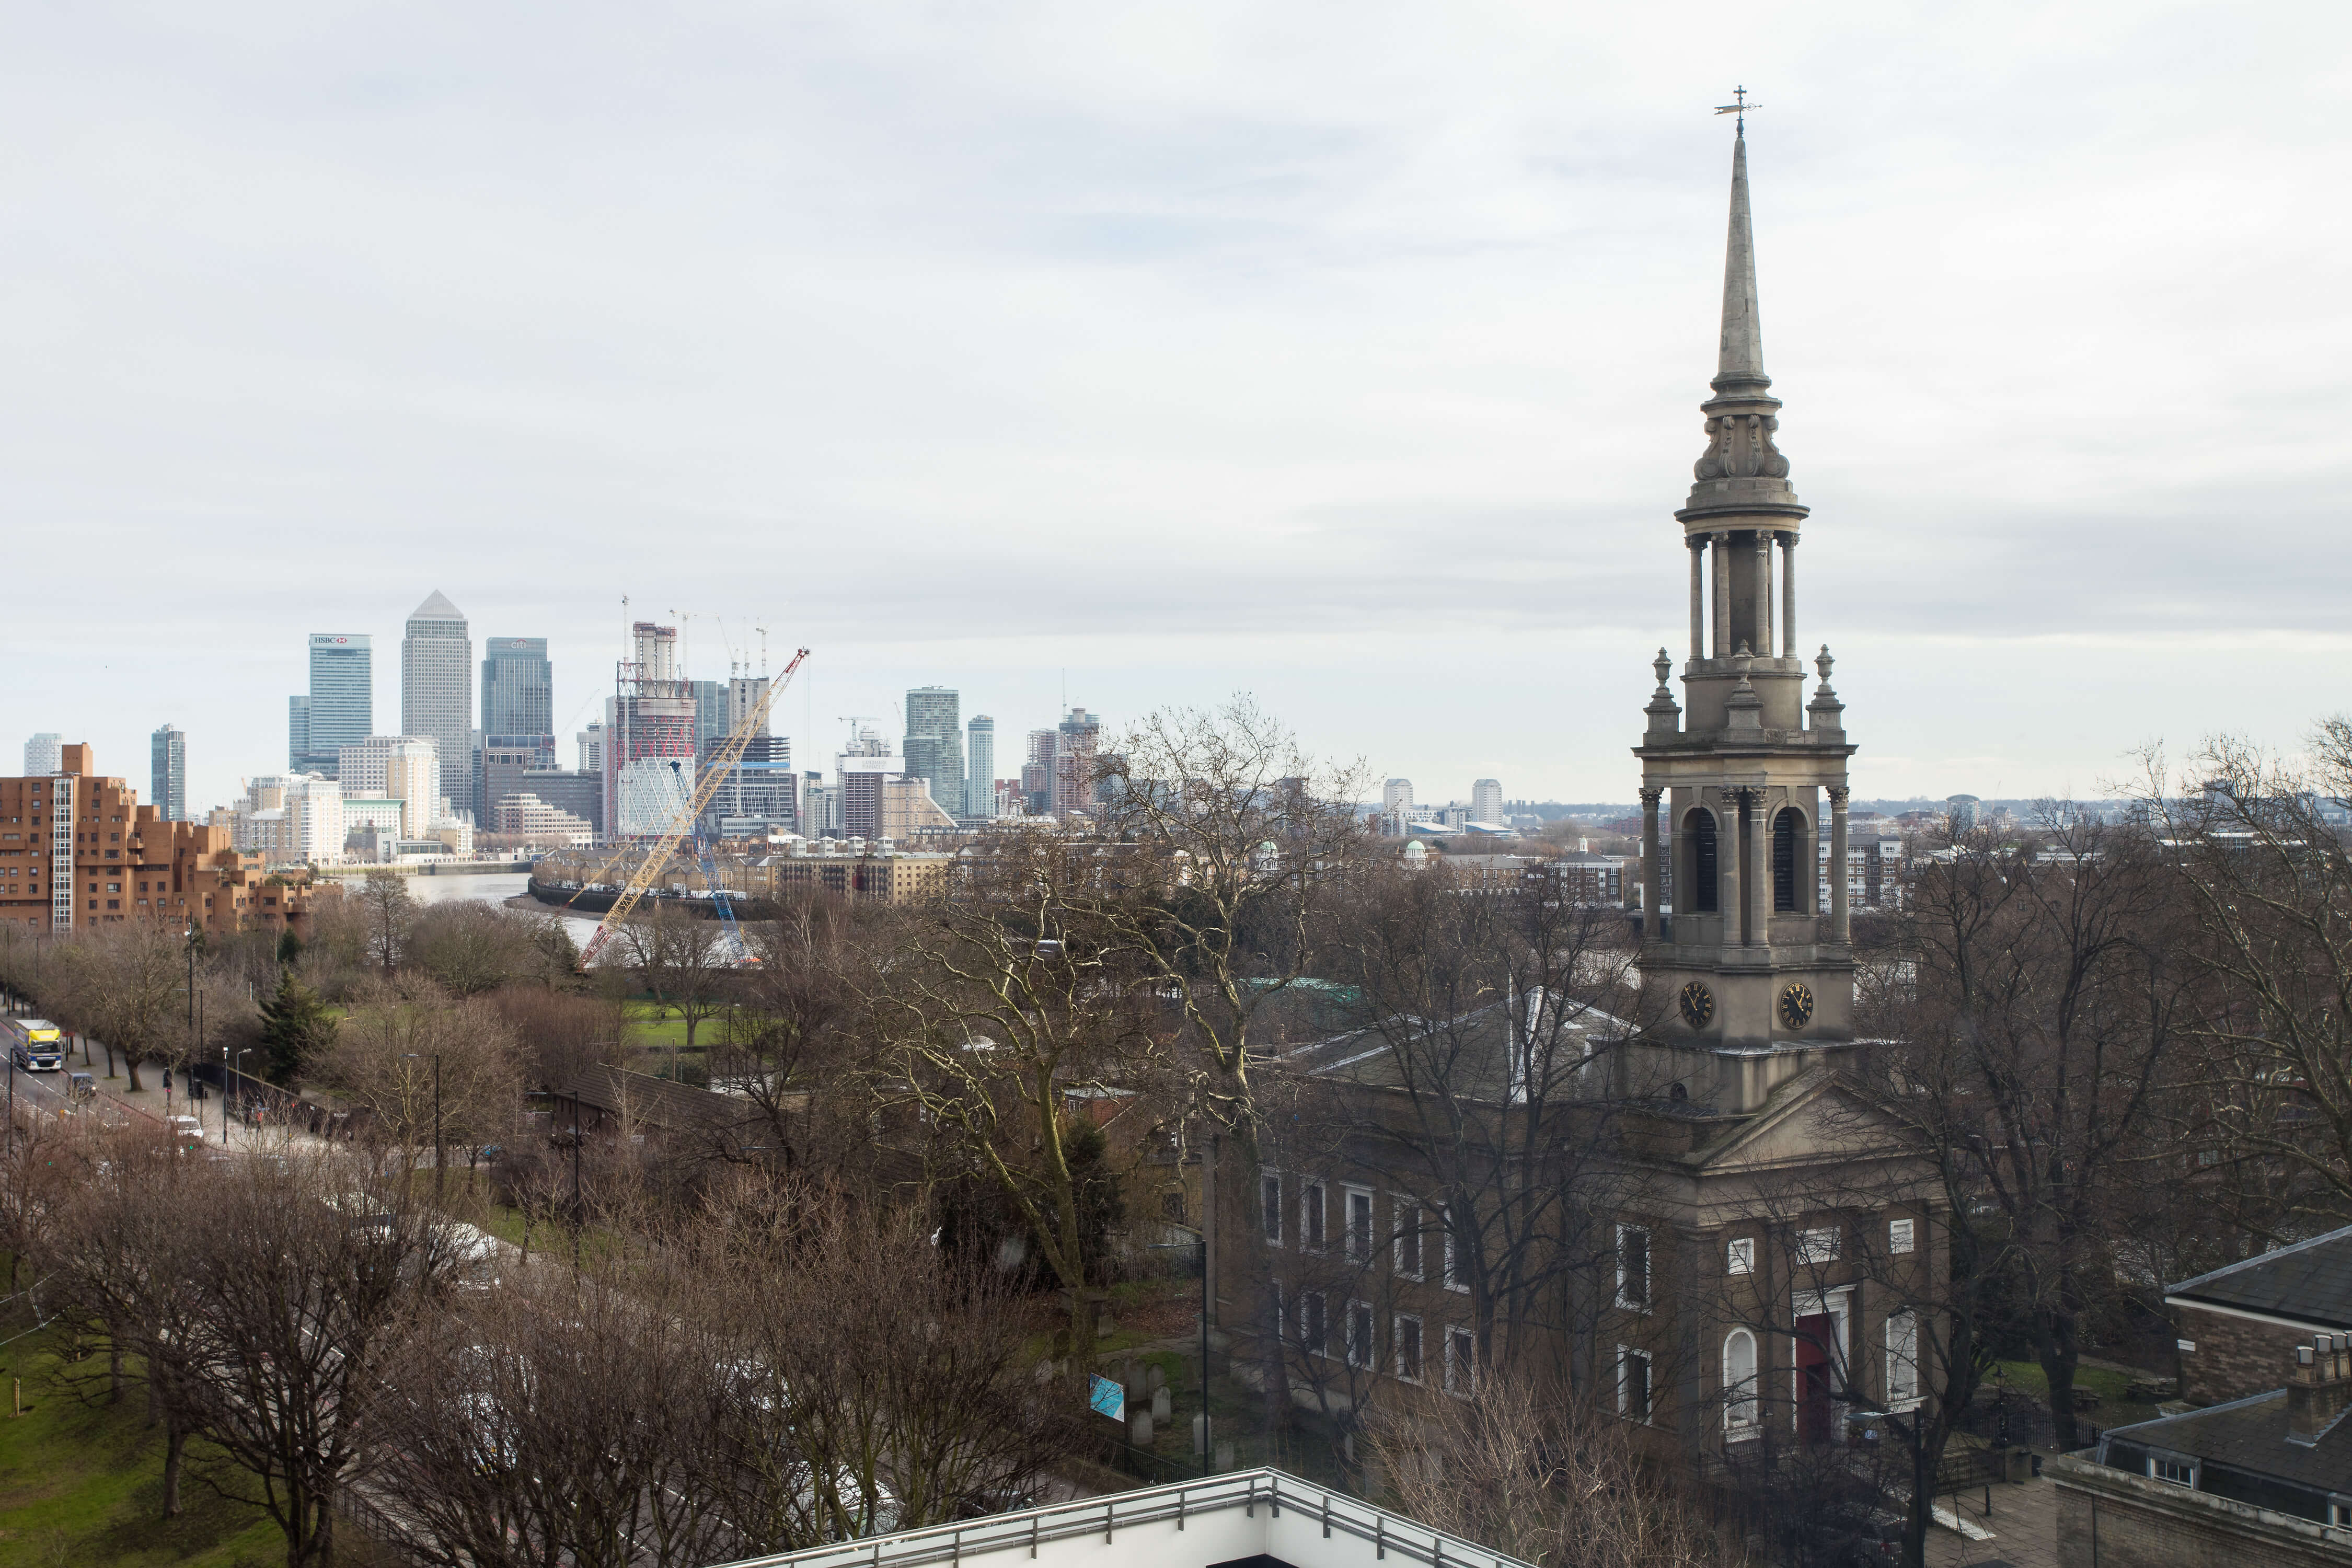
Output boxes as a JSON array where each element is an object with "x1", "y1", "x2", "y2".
[{"x1": 1216, "y1": 124, "x2": 1945, "y2": 1472}]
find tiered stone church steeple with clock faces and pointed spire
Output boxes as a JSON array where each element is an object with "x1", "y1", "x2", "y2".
[{"x1": 1635, "y1": 115, "x2": 1853, "y2": 1110}]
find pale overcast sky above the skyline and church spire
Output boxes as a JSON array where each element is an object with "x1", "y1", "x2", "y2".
[{"x1": 0, "y1": 0, "x2": 2352, "y2": 809}]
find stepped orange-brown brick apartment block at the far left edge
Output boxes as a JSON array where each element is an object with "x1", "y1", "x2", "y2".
[{"x1": 0, "y1": 745, "x2": 327, "y2": 933}]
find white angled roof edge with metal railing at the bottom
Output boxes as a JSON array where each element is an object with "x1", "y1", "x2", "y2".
[{"x1": 706, "y1": 1469, "x2": 1529, "y2": 1568}]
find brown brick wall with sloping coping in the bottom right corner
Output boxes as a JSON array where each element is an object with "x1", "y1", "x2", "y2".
[{"x1": 2044, "y1": 1455, "x2": 2352, "y2": 1568}]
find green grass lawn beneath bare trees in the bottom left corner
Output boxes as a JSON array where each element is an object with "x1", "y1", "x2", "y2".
[{"x1": 0, "y1": 1335, "x2": 285, "y2": 1568}]
